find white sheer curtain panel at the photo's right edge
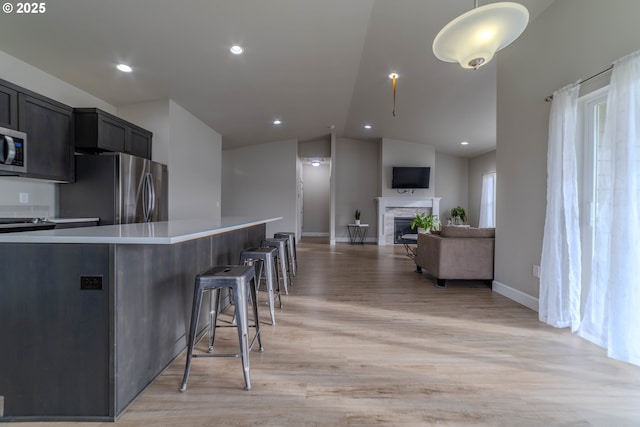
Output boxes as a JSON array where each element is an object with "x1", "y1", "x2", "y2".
[{"x1": 578, "y1": 51, "x2": 640, "y2": 365}]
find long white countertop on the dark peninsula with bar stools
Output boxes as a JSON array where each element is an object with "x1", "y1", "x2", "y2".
[{"x1": 0, "y1": 217, "x2": 282, "y2": 245}]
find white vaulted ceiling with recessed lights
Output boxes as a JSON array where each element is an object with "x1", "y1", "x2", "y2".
[{"x1": 0, "y1": 0, "x2": 554, "y2": 156}]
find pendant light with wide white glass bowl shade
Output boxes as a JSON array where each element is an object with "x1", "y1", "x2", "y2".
[{"x1": 433, "y1": 0, "x2": 529, "y2": 70}]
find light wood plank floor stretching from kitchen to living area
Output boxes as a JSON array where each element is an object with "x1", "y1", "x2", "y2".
[{"x1": 20, "y1": 239, "x2": 640, "y2": 427}]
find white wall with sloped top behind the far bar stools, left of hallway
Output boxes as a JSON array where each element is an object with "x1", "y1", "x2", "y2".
[{"x1": 222, "y1": 139, "x2": 298, "y2": 235}]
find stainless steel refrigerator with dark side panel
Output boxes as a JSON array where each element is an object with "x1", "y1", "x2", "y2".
[{"x1": 58, "y1": 153, "x2": 169, "y2": 225}]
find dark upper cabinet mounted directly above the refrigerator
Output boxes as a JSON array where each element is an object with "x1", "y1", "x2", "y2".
[{"x1": 73, "y1": 108, "x2": 153, "y2": 159}]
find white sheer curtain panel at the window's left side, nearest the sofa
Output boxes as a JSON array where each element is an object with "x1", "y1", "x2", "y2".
[{"x1": 538, "y1": 84, "x2": 581, "y2": 331}]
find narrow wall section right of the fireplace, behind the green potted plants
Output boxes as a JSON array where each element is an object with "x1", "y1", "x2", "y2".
[{"x1": 430, "y1": 153, "x2": 469, "y2": 224}]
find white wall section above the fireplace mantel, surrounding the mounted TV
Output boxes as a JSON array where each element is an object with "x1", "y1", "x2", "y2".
[{"x1": 378, "y1": 138, "x2": 441, "y2": 198}]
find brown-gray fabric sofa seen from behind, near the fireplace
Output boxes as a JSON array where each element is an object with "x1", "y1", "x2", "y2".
[{"x1": 414, "y1": 226, "x2": 495, "y2": 287}]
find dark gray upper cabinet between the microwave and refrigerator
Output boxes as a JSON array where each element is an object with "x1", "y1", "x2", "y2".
[{"x1": 18, "y1": 92, "x2": 74, "y2": 182}]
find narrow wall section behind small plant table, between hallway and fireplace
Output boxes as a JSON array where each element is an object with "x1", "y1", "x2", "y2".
[{"x1": 332, "y1": 138, "x2": 380, "y2": 242}]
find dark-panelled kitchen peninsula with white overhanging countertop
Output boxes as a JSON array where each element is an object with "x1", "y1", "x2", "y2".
[{"x1": 0, "y1": 218, "x2": 280, "y2": 422}]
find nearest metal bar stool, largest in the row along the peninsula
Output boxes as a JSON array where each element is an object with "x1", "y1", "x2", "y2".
[{"x1": 180, "y1": 265, "x2": 264, "y2": 391}]
